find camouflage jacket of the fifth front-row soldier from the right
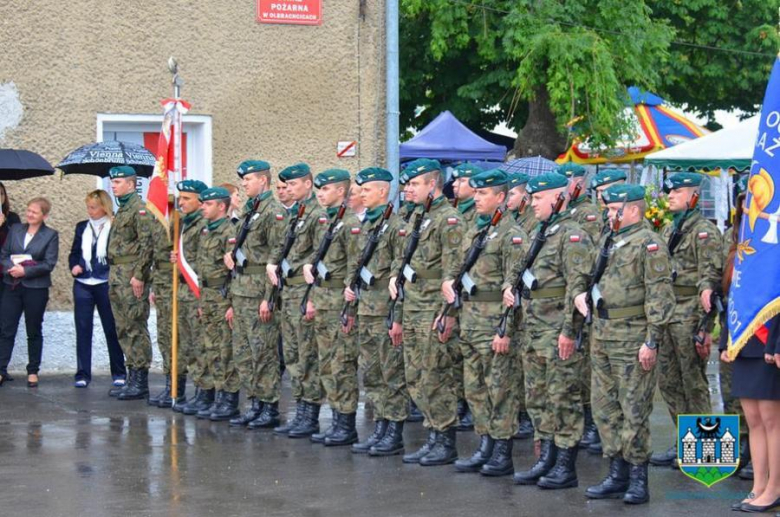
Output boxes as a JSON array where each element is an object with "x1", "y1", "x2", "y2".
[{"x1": 347, "y1": 206, "x2": 406, "y2": 323}]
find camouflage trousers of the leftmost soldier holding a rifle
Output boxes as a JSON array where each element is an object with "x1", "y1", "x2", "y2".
[{"x1": 232, "y1": 295, "x2": 282, "y2": 402}]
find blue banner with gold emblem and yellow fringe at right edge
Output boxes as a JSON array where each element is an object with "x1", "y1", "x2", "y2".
[{"x1": 728, "y1": 56, "x2": 780, "y2": 358}]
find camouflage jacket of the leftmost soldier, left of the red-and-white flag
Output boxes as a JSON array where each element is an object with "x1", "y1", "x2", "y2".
[{"x1": 107, "y1": 193, "x2": 155, "y2": 282}]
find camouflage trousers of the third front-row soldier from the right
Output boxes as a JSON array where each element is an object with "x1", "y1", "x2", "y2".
[{"x1": 459, "y1": 329, "x2": 520, "y2": 440}]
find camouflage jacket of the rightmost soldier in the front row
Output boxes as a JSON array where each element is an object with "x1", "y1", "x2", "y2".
[{"x1": 593, "y1": 222, "x2": 674, "y2": 344}]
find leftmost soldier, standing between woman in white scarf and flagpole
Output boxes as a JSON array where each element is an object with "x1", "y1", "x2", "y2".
[{"x1": 107, "y1": 165, "x2": 158, "y2": 400}]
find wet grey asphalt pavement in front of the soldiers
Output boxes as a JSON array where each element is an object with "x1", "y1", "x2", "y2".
[{"x1": 0, "y1": 364, "x2": 750, "y2": 517}]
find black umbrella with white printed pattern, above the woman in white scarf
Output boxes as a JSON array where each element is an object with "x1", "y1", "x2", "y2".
[{"x1": 57, "y1": 140, "x2": 155, "y2": 178}]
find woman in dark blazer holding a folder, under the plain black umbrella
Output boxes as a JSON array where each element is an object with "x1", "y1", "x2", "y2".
[{"x1": 0, "y1": 197, "x2": 60, "y2": 388}]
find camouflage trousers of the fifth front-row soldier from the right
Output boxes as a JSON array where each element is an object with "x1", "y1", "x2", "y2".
[{"x1": 358, "y1": 316, "x2": 409, "y2": 422}]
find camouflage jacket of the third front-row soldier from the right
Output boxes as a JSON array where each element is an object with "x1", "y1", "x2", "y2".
[{"x1": 460, "y1": 217, "x2": 529, "y2": 330}]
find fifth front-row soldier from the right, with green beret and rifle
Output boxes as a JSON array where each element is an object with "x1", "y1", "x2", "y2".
[{"x1": 344, "y1": 167, "x2": 409, "y2": 456}]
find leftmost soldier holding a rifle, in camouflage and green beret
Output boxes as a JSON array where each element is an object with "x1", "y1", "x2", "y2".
[{"x1": 224, "y1": 160, "x2": 286, "y2": 429}]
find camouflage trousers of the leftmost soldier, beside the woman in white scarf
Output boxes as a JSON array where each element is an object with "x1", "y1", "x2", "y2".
[{"x1": 108, "y1": 278, "x2": 152, "y2": 370}]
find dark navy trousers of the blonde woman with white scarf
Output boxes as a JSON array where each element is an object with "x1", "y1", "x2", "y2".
[{"x1": 73, "y1": 282, "x2": 125, "y2": 382}]
